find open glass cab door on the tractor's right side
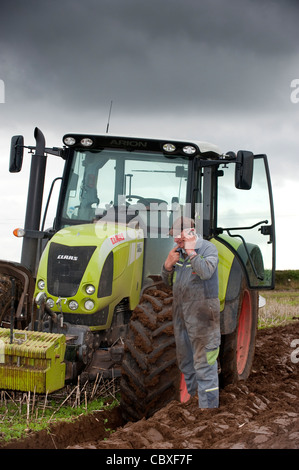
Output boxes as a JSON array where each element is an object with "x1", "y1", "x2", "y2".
[{"x1": 215, "y1": 152, "x2": 275, "y2": 290}]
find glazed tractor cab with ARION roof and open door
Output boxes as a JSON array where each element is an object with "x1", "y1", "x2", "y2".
[{"x1": 55, "y1": 134, "x2": 275, "y2": 288}]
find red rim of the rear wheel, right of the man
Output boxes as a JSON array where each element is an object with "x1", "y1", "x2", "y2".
[{"x1": 237, "y1": 290, "x2": 252, "y2": 375}]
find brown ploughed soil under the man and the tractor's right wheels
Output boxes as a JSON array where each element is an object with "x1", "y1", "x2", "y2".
[{"x1": 0, "y1": 321, "x2": 299, "y2": 449}]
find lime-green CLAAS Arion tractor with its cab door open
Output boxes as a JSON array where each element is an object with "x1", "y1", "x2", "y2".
[{"x1": 0, "y1": 128, "x2": 275, "y2": 420}]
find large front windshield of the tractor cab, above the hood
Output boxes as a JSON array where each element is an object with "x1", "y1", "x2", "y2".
[{"x1": 62, "y1": 150, "x2": 188, "y2": 230}]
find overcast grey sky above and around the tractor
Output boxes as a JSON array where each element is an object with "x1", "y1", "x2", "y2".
[{"x1": 0, "y1": 0, "x2": 299, "y2": 267}]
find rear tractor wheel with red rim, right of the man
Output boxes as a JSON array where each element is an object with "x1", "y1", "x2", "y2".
[{"x1": 219, "y1": 281, "x2": 258, "y2": 387}]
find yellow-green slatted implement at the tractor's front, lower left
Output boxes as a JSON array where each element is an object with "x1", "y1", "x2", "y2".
[{"x1": 0, "y1": 328, "x2": 66, "y2": 393}]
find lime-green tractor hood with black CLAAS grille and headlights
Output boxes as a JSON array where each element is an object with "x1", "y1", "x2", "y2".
[{"x1": 35, "y1": 221, "x2": 143, "y2": 327}]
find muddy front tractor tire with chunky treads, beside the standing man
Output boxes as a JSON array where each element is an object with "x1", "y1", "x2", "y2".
[{"x1": 120, "y1": 282, "x2": 181, "y2": 421}]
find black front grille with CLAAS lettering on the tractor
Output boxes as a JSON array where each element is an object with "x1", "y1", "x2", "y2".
[{"x1": 47, "y1": 242, "x2": 96, "y2": 297}]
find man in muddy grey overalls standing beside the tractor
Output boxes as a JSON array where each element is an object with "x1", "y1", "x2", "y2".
[{"x1": 162, "y1": 217, "x2": 221, "y2": 408}]
